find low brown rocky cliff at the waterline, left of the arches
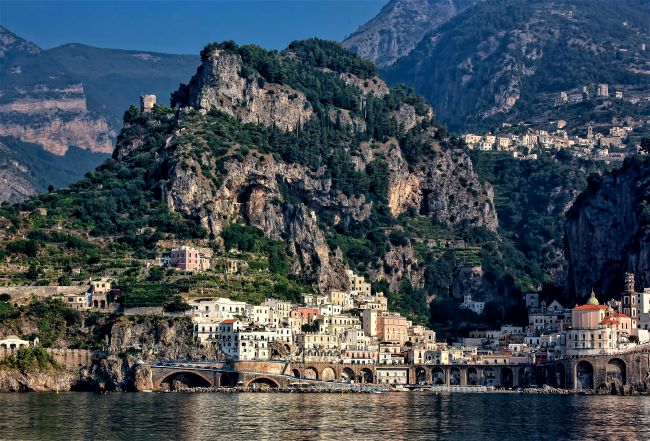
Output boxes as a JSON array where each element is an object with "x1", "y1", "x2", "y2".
[{"x1": 0, "y1": 315, "x2": 217, "y2": 392}]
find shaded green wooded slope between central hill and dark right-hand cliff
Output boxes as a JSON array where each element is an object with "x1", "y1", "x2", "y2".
[{"x1": 471, "y1": 152, "x2": 604, "y2": 290}]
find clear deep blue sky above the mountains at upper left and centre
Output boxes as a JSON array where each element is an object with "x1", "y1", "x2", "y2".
[{"x1": 0, "y1": 0, "x2": 388, "y2": 54}]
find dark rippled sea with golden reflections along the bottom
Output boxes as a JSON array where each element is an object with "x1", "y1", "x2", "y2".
[{"x1": 0, "y1": 392, "x2": 650, "y2": 441}]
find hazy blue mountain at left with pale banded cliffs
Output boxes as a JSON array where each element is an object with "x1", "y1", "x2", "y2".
[{"x1": 0, "y1": 26, "x2": 198, "y2": 201}]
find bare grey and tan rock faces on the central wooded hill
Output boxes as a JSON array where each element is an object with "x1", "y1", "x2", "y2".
[{"x1": 158, "y1": 46, "x2": 498, "y2": 290}]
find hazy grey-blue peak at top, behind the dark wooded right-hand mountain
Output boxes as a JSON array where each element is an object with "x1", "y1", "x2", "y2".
[{"x1": 343, "y1": 0, "x2": 478, "y2": 67}]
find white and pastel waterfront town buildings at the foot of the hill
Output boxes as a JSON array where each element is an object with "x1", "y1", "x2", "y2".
[{"x1": 0, "y1": 245, "x2": 650, "y2": 387}]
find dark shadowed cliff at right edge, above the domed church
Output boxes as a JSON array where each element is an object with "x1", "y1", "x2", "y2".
[{"x1": 565, "y1": 157, "x2": 650, "y2": 299}]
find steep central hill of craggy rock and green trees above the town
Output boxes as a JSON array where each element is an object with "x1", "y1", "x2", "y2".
[{"x1": 4, "y1": 40, "x2": 504, "y2": 321}]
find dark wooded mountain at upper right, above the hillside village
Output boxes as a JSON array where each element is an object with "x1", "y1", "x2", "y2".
[{"x1": 382, "y1": 0, "x2": 650, "y2": 128}]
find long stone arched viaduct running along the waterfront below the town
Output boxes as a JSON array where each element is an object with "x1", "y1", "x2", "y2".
[{"x1": 150, "y1": 350, "x2": 650, "y2": 393}]
